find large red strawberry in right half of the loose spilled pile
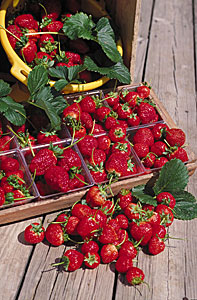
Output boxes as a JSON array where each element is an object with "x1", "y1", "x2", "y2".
[{"x1": 130, "y1": 221, "x2": 152, "y2": 246}]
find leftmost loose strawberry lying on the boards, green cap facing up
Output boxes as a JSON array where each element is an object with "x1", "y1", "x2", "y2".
[{"x1": 24, "y1": 223, "x2": 45, "y2": 244}]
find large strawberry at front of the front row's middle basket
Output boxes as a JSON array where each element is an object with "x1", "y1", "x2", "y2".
[{"x1": 105, "y1": 153, "x2": 127, "y2": 178}]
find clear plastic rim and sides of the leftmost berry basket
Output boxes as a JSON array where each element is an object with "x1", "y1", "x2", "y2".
[{"x1": 0, "y1": 149, "x2": 38, "y2": 209}]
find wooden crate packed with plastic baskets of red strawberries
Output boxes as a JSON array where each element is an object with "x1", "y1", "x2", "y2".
[{"x1": 0, "y1": 84, "x2": 197, "y2": 224}]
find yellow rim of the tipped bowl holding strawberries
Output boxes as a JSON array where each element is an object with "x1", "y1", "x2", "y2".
[{"x1": 0, "y1": 0, "x2": 123, "y2": 94}]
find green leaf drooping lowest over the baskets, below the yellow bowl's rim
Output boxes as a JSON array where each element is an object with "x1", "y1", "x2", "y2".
[{"x1": 35, "y1": 87, "x2": 61, "y2": 130}]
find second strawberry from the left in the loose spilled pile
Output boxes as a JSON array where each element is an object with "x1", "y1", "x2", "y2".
[{"x1": 45, "y1": 224, "x2": 64, "y2": 246}]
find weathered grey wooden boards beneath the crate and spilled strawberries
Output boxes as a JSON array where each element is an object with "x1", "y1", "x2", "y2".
[{"x1": 0, "y1": 0, "x2": 197, "y2": 300}]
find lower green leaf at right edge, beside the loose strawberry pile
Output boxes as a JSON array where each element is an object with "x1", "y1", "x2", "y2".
[{"x1": 173, "y1": 191, "x2": 197, "y2": 220}]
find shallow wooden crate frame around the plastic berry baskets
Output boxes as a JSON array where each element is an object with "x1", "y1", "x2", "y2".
[{"x1": 0, "y1": 84, "x2": 197, "y2": 224}]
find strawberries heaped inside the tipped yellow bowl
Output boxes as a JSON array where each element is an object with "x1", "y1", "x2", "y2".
[{"x1": 6, "y1": 0, "x2": 95, "y2": 82}]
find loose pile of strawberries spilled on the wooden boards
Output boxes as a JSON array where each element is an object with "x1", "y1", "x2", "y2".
[{"x1": 24, "y1": 185, "x2": 176, "y2": 285}]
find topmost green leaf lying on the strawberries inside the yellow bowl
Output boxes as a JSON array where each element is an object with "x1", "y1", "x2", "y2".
[{"x1": 63, "y1": 12, "x2": 95, "y2": 40}]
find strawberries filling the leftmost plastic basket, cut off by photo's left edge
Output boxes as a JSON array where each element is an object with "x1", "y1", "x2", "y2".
[{"x1": 0, "y1": 155, "x2": 33, "y2": 206}]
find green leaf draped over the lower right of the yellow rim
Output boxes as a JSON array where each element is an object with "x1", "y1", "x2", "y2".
[{"x1": 84, "y1": 57, "x2": 131, "y2": 84}]
